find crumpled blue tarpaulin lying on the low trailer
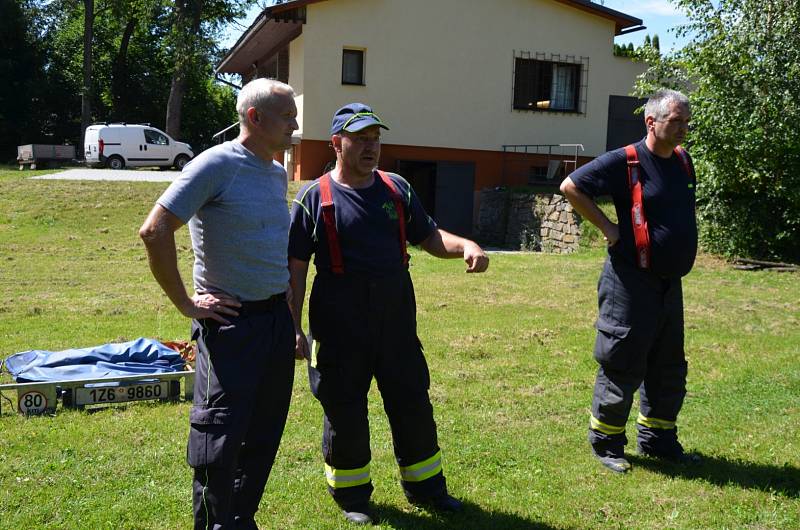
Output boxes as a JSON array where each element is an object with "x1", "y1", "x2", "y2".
[{"x1": 5, "y1": 338, "x2": 185, "y2": 383}]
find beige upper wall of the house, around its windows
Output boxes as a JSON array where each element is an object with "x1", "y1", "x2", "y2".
[{"x1": 290, "y1": 0, "x2": 644, "y2": 156}]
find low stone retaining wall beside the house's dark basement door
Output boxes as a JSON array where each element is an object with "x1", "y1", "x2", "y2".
[{"x1": 475, "y1": 188, "x2": 581, "y2": 254}]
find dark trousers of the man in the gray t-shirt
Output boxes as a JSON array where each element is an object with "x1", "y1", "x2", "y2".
[{"x1": 187, "y1": 295, "x2": 294, "y2": 529}]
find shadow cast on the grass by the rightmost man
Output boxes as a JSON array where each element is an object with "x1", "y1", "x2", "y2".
[{"x1": 630, "y1": 453, "x2": 800, "y2": 498}]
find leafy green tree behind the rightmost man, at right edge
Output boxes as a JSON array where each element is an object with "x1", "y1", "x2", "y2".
[{"x1": 637, "y1": 0, "x2": 800, "y2": 262}]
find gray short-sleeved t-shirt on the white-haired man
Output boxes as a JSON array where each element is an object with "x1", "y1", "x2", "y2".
[{"x1": 157, "y1": 141, "x2": 289, "y2": 301}]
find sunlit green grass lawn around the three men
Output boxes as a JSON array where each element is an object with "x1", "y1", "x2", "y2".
[{"x1": 0, "y1": 169, "x2": 800, "y2": 530}]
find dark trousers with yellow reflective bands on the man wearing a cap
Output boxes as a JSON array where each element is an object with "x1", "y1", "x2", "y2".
[{"x1": 309, "y1": 271, "x2": 446, "y2": 509}]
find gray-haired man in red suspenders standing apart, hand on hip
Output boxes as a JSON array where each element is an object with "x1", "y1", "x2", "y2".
[{"x1": 561, "y1": 90, "x2": 697, "y2": 473}]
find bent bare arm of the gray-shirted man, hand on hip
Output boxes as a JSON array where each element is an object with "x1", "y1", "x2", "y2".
[{"x1": 139, "y1": 204, "x2": 241, "y2": 324}]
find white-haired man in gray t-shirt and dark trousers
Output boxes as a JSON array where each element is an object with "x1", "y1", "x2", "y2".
[{"x1": 139, "y1": 79, "x2": 298, "y2": 528}]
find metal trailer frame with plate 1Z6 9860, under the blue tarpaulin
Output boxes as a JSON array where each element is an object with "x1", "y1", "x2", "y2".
[{"x1": 0, "y1": 370, "x2": 195, "y2": 416}]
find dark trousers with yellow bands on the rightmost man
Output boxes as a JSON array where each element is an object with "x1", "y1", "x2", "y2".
[{"x1": 589, "y1": 257, "x2": 687, "y2": 456}]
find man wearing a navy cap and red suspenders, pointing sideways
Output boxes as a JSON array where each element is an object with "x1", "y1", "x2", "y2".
[{"x1": 289, "y1": 103, "x2": 489, "y2": 524}]
